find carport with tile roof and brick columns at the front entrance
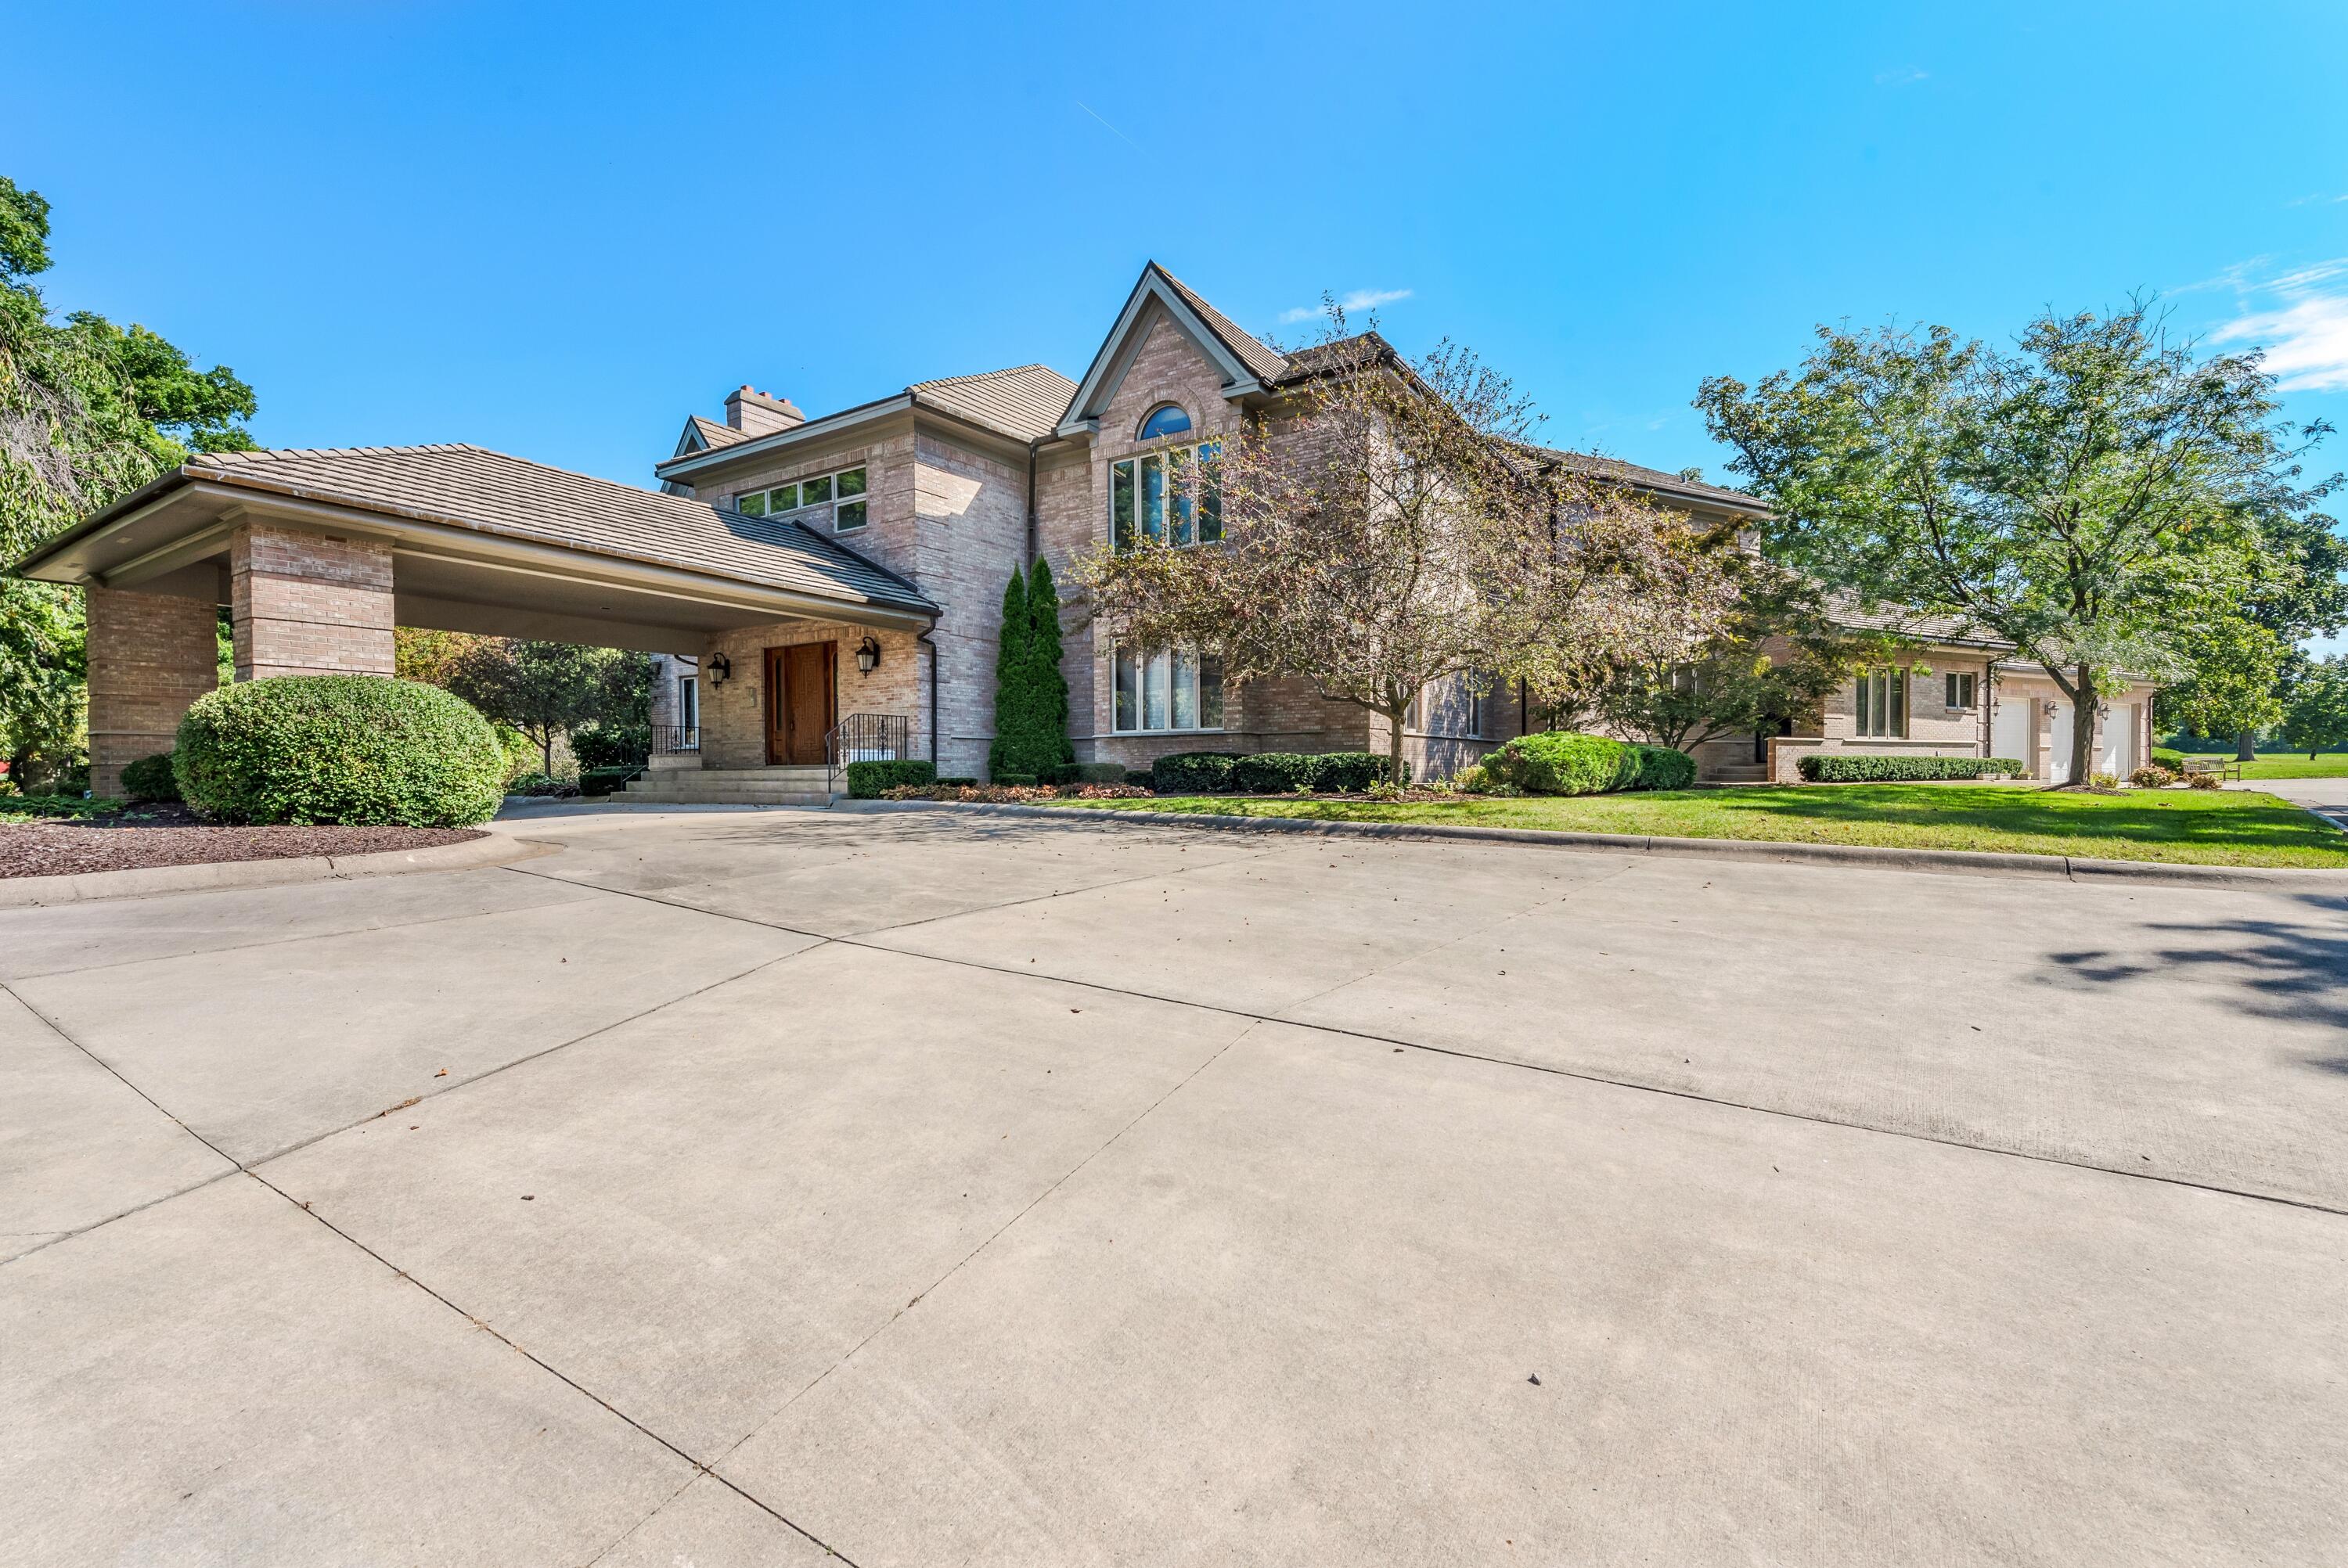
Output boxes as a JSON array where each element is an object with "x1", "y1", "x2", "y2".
[{"x1": 14, "y1": 444, "x2": 937, "y2": 796}]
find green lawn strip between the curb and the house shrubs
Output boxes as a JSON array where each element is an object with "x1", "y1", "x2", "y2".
[{"x1": 1071, "y1": 784, "x2": 2348, "y2": 866}]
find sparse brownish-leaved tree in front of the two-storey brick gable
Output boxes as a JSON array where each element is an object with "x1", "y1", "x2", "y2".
[{"x1": 1082, "y1": 305, "x2": 1730, "y2": 779}]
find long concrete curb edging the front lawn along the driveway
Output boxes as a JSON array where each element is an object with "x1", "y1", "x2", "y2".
[{"x1": 831, "y1": 800, "x2": 2348, "y2": 894}]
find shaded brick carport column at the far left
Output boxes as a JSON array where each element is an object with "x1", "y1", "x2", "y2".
[{"x1": 85, "y1": 587, "x2": 221, "y2": 796}]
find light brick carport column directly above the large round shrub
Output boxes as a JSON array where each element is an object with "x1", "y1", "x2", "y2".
[{"x1": 228, "y1": 523, "x2": 392, "y2": 681}]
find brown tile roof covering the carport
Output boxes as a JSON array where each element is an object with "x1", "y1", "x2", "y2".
[{"x1": 181, "y1": 444, "x2": 937, "y2": 610}]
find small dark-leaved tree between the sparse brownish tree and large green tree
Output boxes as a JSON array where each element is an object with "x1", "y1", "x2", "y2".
[{"x1": 1590, "y1": 556, "x2": 1888, "y2": 751}]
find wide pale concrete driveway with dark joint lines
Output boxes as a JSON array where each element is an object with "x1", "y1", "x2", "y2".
[{"x1": 0, "y1": 812, "x2": 2348, "y2": 1568}]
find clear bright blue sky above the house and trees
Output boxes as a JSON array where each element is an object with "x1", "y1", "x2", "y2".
[{"x1": 0, "y1": 0, "x2": 2348, "y2": 638}]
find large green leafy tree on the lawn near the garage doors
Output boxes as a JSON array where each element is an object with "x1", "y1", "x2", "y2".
[{"x1": 1698, "y1": 303, "x2": 2329, "y2": 779}]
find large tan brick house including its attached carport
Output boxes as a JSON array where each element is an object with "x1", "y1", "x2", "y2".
[{"x1": 19, "y1": 263, "x2": 2151, "y2": 800}]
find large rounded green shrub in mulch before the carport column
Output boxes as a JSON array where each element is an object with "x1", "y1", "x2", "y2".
[{"x1": 171, "y1": 676, "x2": 505, "y2": 829}]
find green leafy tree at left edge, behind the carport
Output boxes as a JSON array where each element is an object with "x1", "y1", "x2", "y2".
[{"x1": 0, "y1": 176, "x2": 256, "y2": 775}]
